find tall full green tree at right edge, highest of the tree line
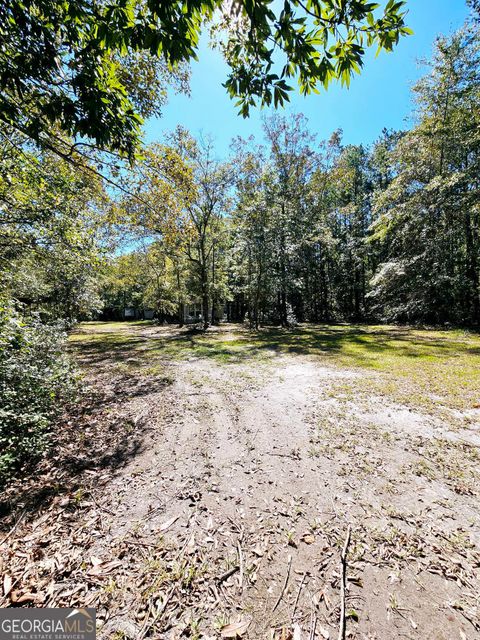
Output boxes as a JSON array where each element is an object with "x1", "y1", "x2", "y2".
[{"x1": 371, "y1": 27, "x2": 480, "y2": 325}]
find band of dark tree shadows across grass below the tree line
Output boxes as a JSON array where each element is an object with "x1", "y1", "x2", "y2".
[{"x1": 70, "y1": 325, "x2": 480, "y2": 368}]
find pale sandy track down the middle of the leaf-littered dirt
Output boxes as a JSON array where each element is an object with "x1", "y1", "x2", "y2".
[{"x1": 92, "y1": 357, "x2": 475, "y2": 640}]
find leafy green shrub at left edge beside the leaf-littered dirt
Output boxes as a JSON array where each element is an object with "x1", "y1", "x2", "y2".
[{"x1": 0, "y1": 301, "x2": 75, "y2": 484}]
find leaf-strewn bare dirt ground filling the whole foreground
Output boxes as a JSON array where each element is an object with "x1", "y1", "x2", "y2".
[{"x1": 0, "y1": 330, "x2": 480, "y2": 640}]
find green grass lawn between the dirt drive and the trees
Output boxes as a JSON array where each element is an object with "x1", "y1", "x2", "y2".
[{"x1": 70, "y1": 321, "x2": 480, "y2": 409}]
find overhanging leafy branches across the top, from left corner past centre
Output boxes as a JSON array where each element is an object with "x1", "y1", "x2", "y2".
[{"x1": 0, "y1": 0, "x2": 410, "y2": 158}]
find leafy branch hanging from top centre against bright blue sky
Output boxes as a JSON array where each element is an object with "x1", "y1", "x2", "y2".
[{"x1": 216, "y1": 0, "x2": 412, "y2": 116}]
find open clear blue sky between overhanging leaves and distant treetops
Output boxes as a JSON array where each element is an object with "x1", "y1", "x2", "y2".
[{"x1": 146, "y1": 0, "x2": 468, "y2": 158}]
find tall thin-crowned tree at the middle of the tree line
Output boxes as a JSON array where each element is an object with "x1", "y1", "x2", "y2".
[{"x1": 233, "y1": 115, "x2": 338, "y2": 327}]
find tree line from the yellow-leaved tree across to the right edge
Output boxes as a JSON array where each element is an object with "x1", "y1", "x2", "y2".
[{"x1": 102, "y1": 24, "x2": 480, "y2": 327}]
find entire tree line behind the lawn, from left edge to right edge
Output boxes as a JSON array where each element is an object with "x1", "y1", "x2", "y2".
[{"x1": 0, "y1": 21, "x2": 480, "y2": 327}]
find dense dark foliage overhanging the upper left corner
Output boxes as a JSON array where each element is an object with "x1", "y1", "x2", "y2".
[{"x1": 0, "y1": 0, "x2": 188, "y2": 156}]
